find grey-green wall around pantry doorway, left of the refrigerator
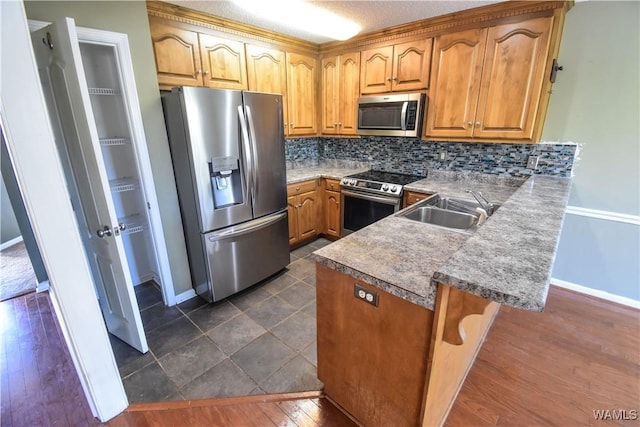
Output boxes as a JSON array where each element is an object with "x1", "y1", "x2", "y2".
[{"x1": 23, "y1": 0, "x2": 192, "y2": 295}]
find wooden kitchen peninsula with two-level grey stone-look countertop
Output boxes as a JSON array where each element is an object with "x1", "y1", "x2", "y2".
[{"x1": 314, "y1": 171, "x2": 570, "y2": 425}]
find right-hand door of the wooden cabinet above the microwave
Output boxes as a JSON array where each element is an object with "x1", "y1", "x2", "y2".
[{"x1": 391, "y1": 39, "x2": 433, "y2": 91}]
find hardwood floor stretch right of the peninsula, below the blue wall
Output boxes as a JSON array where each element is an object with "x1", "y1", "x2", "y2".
[{"x1": 446, "y1": 286, "x2": 640, "y2": 427}]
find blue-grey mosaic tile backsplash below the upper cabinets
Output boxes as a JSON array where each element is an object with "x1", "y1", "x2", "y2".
[{"x1": 285, "y1": 136, "x2": 578, "y2": 177}]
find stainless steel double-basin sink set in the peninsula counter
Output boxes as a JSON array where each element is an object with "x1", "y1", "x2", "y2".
[{"x1": 398, "y1": 194, "x2": 499, "y2": 231}]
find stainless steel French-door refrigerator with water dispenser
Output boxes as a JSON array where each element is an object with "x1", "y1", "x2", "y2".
[{"x1": 163, "y1": 87, "x2": 289, "y2": 302}]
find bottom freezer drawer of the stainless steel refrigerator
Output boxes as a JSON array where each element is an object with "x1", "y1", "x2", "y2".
[{"x1": 202, "y1": 211, "x2": 290, "y2": 301}]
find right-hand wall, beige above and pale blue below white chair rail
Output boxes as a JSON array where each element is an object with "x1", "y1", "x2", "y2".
[{"x1": 543, "y1": 1, "x2": 640, "y2": 300}]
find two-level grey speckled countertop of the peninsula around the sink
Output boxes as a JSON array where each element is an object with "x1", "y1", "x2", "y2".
[{"x1": 313, "y1": 171, "x2": 571, "y2": 311}]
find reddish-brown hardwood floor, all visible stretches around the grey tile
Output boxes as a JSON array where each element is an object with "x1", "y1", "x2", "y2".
[{"x1": 0, "y1": 287, "x2": 640, "y2": 427}]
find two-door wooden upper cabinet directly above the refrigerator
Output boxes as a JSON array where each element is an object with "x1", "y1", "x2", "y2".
[{"x1": 149, "y1": 18, "x2": 247, "y2": 89}]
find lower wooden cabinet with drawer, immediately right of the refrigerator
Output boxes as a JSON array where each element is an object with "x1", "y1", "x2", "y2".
[{"x1": 287, "y1": 179, "x2": 321, "y2": 246}]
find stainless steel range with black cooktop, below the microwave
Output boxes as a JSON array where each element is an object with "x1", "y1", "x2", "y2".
[{"x1": 340, "y1": 171, "x2": 422, "y2": 236}]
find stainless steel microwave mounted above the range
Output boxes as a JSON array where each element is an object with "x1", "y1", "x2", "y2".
[{"x1": 358, "y1": 93, "x2": 426, "y2": 137}]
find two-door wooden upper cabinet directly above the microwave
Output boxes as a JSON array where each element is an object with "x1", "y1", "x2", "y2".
[{"x1": 360, "y1": 38, "x2": 433, "y2": 95}]
